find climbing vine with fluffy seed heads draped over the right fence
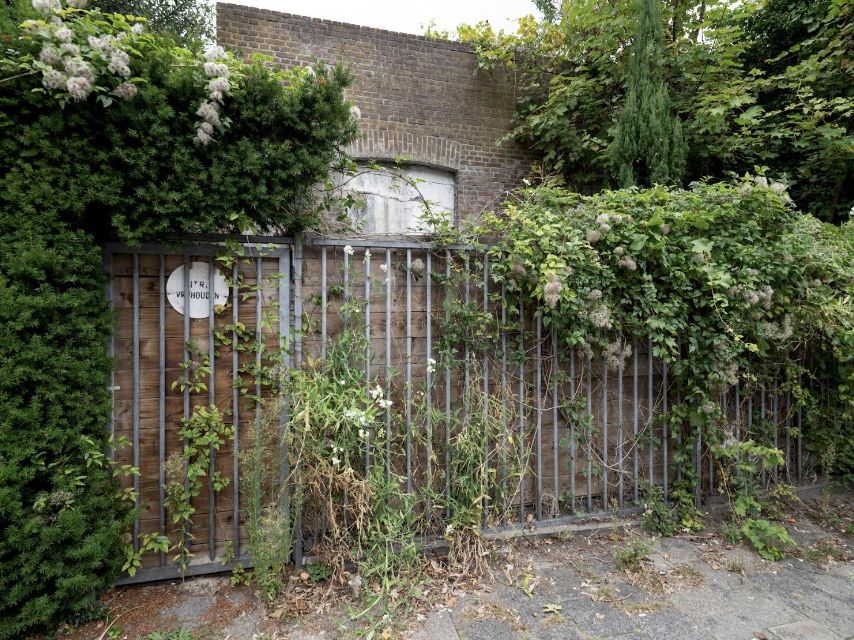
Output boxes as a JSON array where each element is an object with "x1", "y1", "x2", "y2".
[{"x1": 478, "y1": 176, "x2": 854, "y2": 488}]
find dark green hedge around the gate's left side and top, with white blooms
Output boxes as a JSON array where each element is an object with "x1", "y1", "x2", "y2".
[{"x1": 0, "y1": 0, "x2": 355, "y2": 639}]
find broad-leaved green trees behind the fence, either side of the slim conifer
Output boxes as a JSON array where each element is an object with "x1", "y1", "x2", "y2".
[{"x1": 452, "y1": 0, "x2": 854, "y2": 222}]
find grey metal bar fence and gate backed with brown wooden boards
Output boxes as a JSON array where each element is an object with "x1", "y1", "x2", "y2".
[{"x1": 104, "y1": 237, "x2": 804, "y2": 582}]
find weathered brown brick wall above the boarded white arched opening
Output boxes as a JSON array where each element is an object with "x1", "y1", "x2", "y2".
[{"x1": 217, "y1": 3, "x2": 532, "y2": 216}]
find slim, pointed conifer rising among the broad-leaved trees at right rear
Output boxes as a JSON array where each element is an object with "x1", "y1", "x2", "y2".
[{"x1": 610, "y1": 0, "x2": 687, "y2": 187}]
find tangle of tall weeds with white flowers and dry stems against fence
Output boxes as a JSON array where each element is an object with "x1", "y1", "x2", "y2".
[{"x1": 241, "y1": 322, "x2": 527, "y2": 634}]
